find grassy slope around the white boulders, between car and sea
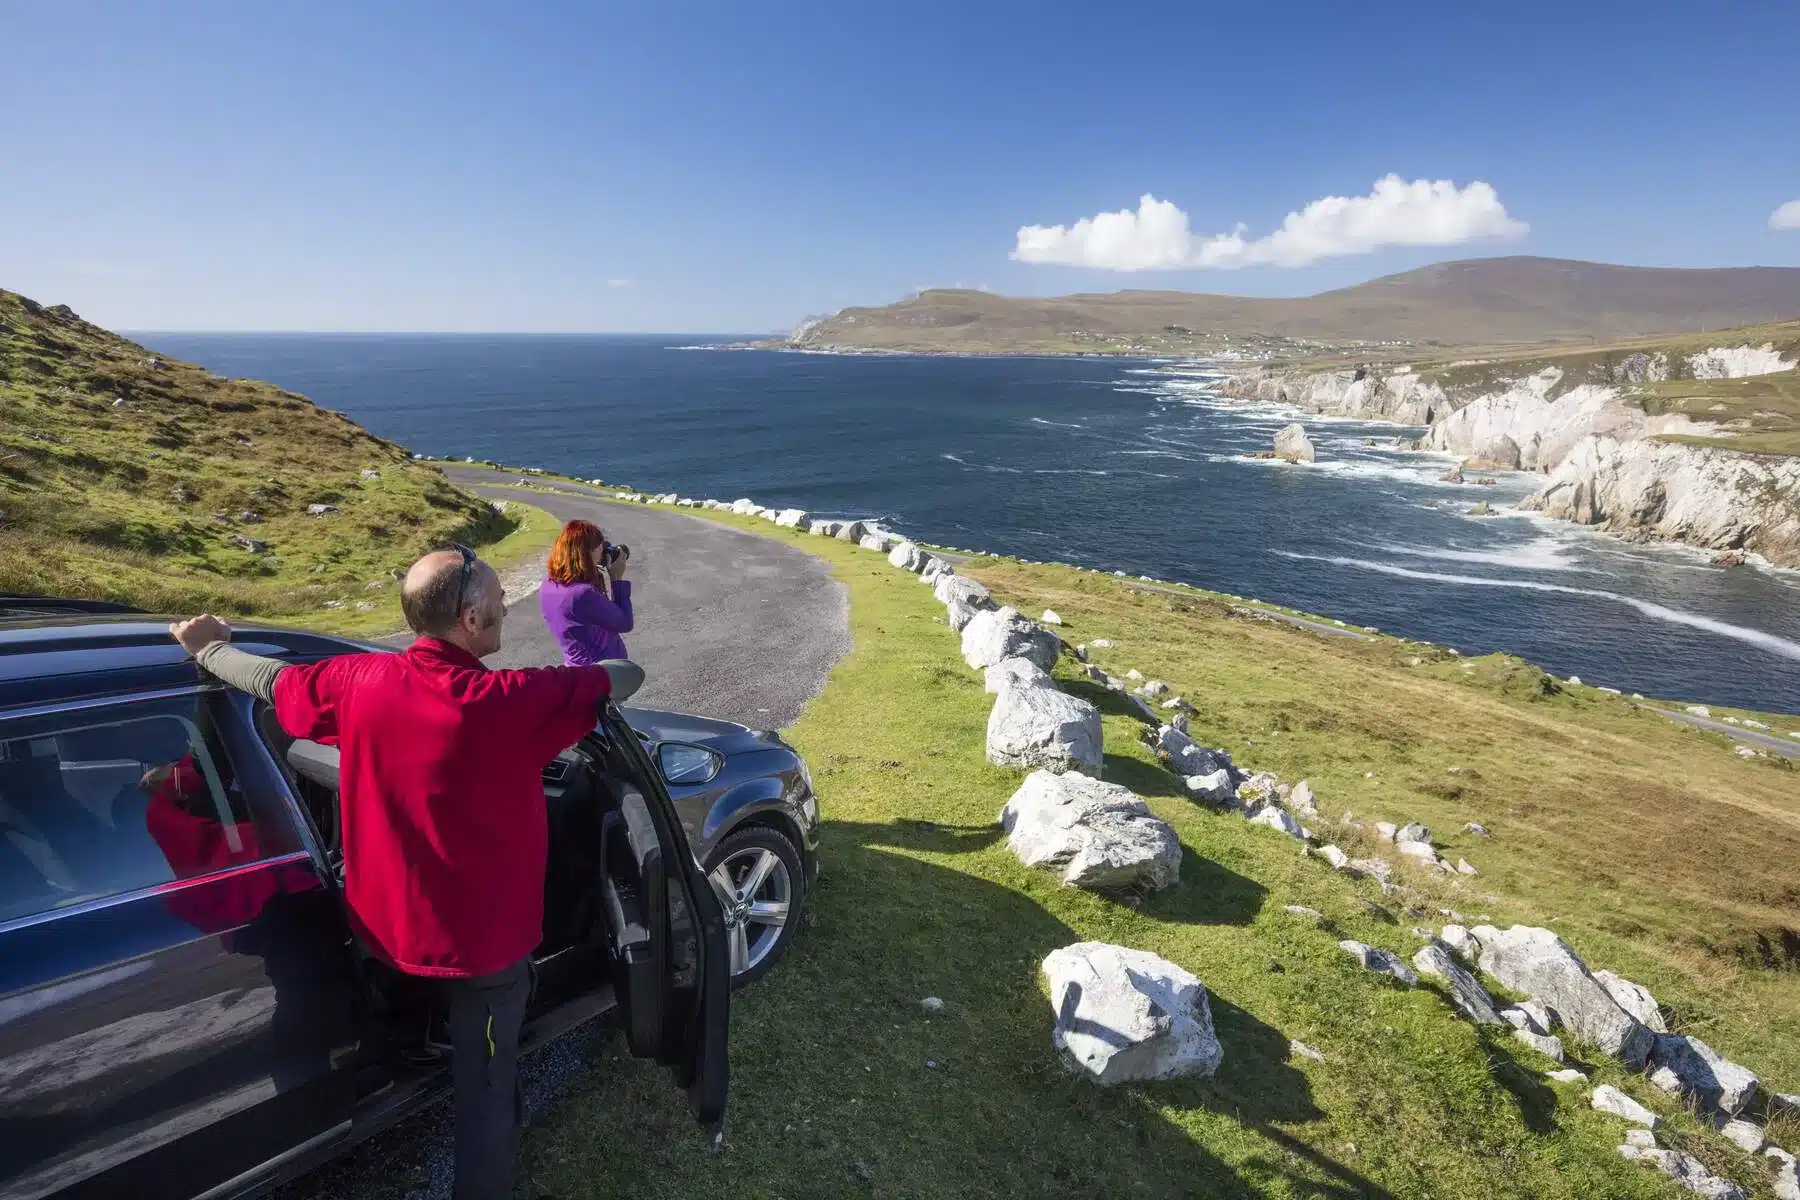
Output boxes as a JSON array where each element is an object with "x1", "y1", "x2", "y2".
[{"x1": 486, "y1": 515, "x2": 1800, "y2": 1198}]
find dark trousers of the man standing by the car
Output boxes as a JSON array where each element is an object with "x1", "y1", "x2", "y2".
[{"x1": 445, "y1": 959, "x2": 533, "y2": 1200}]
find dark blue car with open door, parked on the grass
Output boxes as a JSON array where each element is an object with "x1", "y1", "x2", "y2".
[{"x1": 0, "y1": 596, "x2": 819, "y2": 1200}]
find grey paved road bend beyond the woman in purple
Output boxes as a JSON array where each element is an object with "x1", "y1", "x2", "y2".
[{"x1": 473, "y1": 484, "x2": 850, "y2": 729}]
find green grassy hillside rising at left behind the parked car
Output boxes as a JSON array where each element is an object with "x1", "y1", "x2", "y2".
[{"x1": 0, "y1": 291, "x2": 545, "y2": 628}]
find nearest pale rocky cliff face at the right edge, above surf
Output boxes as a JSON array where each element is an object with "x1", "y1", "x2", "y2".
[{"x1": 1519, "y1": 434, "x2": 1800, "y2": 567}]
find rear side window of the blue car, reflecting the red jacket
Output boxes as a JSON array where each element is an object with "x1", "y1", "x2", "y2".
[{"x1": 0, "y1": 694, "x2": 301, "y2": 921}]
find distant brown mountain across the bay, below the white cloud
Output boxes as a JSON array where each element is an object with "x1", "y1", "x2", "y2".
[{"x1": 792, "y1": 257, "x2": 1800, "y2": 353}]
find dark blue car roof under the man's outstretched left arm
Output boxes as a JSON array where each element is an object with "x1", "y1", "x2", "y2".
[{"x1": 0, "y1": 611, "x2": 379, "y2": 712}]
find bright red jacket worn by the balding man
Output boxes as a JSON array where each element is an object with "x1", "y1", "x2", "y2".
[{"x1": 275, "y1": 637, "x2": 612, "y2": 979}]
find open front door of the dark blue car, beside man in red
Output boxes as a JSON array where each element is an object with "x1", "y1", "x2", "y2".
[{"x1": 586, "y1": 702, "x2": 731, "y2": 1133}]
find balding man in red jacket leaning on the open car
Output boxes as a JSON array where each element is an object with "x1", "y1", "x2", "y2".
[{"x1": 169, "y1": 545, "x2": 643, "y2": 1200}]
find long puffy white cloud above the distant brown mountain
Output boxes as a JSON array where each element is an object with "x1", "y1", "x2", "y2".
[{"x1": 1012, "y1": 175, "x2": 1530, "y2": 272}]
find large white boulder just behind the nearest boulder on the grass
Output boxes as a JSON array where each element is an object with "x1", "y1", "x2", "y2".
[{"x1": 1001, "y1": 770, "x2": 1181, "y2": 891}]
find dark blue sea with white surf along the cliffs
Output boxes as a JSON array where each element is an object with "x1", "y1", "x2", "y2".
[{"x1": 139, "y1": 333, "x2": 1800, "y2": 712}]
